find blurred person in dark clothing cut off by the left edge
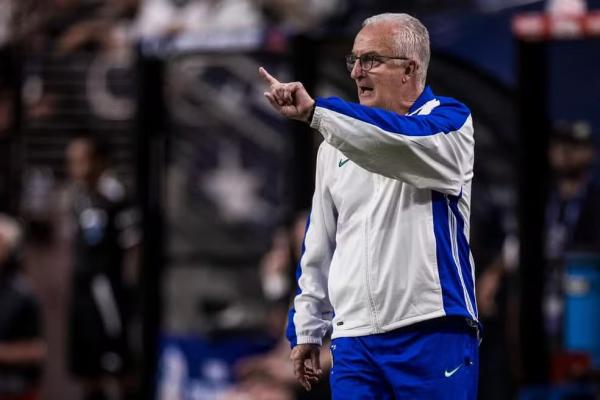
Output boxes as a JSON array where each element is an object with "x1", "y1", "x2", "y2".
[{"x1": 0, "y1": 215, "x2": 46, "y2": 400}]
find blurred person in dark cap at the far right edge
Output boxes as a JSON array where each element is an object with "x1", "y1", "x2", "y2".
[{"x1": 544, "y1": 121, "x2": 600, "y2": 351}]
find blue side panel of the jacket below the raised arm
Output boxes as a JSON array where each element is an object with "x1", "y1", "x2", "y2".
[{"x1": 431, "y1": 190, "x2": 469, "y2": 317}]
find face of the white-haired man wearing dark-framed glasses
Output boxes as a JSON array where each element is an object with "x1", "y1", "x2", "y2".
[{"x1": 350, "y1": 22, "x2": 412, "y2": 111}]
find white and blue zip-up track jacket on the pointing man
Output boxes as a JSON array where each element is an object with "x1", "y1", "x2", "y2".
[{"x1": 287, "y1": 87, "x2": 478, "y2": 346}]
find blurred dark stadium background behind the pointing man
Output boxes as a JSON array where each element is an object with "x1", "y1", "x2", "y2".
[{"x1": 0, "y1": 0, "x2": 600, "y2": 400}]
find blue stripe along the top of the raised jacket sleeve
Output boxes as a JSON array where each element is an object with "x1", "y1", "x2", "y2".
[{"x1": 316, "y1": 97, "x2": 470, "y2": 136}]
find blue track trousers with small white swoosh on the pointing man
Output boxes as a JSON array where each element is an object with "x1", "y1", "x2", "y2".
[{"x1": 330, "y1": 318, "x2": 479, "y2": 400}]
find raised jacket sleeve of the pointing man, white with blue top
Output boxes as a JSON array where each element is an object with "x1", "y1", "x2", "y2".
[{"x1": 311, "y1": 98, "x2": 474, "y2": 195}]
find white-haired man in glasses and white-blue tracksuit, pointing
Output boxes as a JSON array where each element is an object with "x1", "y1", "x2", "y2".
[{"x1": 259, "y1": 14, "x2": 479, "y2": 400}]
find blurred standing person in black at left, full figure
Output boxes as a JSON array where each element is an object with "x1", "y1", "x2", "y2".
[{"x1": 67, "y1": 137, "x2": 138, "y2": 400}]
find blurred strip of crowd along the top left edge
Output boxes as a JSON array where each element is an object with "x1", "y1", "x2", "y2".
[{"x1": 0, "y1": 0, "x2": 349, "y2": 50}]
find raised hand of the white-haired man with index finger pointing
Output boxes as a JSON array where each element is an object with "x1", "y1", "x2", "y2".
[{"x1": 258, "y1": 67, "x2": 315, "y2": 123}]
